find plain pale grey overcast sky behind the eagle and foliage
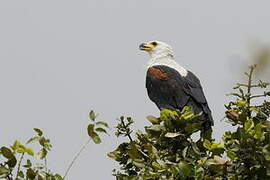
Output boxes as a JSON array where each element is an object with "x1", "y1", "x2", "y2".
[{"x1": 0, "y1": 0, "x2": 270, "y2": 180}]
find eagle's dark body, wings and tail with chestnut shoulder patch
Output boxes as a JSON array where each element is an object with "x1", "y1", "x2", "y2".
[{"x1": 146, "y1": 65, "x2": 213, "y2": 129}]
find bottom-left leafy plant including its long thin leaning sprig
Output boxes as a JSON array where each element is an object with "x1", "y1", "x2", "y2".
[{"x1": 0, "y1": 111, "x2": 109, "y2": 180}]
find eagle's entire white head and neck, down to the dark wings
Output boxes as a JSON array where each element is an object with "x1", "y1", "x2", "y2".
[{"x1": 140, "y1": 41, "x2": 188, "y2": 76}]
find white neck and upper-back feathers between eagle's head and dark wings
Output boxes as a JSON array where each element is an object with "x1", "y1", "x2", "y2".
[{"x1": 147, "y1": 57, "x2": 188, "y2": 76}]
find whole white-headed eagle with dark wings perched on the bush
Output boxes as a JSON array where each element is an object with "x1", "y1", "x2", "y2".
[{"x1": 140, "y1": 41, "x2": 214, "y2": 130}]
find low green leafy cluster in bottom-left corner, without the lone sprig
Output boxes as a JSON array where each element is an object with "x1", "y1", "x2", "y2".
[{"x1": 0, "y1": 128, "x2": 63, "y2": 180}]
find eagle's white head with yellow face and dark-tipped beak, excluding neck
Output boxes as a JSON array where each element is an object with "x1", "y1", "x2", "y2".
[{"x1": 140, "y1": 41, "x2": 173, "y2": 59}]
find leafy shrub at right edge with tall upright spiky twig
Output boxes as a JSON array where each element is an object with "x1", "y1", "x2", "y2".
[{"x1": 222, "y1": 65, "x2": 270, "y2": 179}]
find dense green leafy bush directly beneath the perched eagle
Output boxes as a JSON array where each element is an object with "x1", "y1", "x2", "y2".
[{"x1": 108, "y1": 107, "x2": 225, "y2": 180}]
